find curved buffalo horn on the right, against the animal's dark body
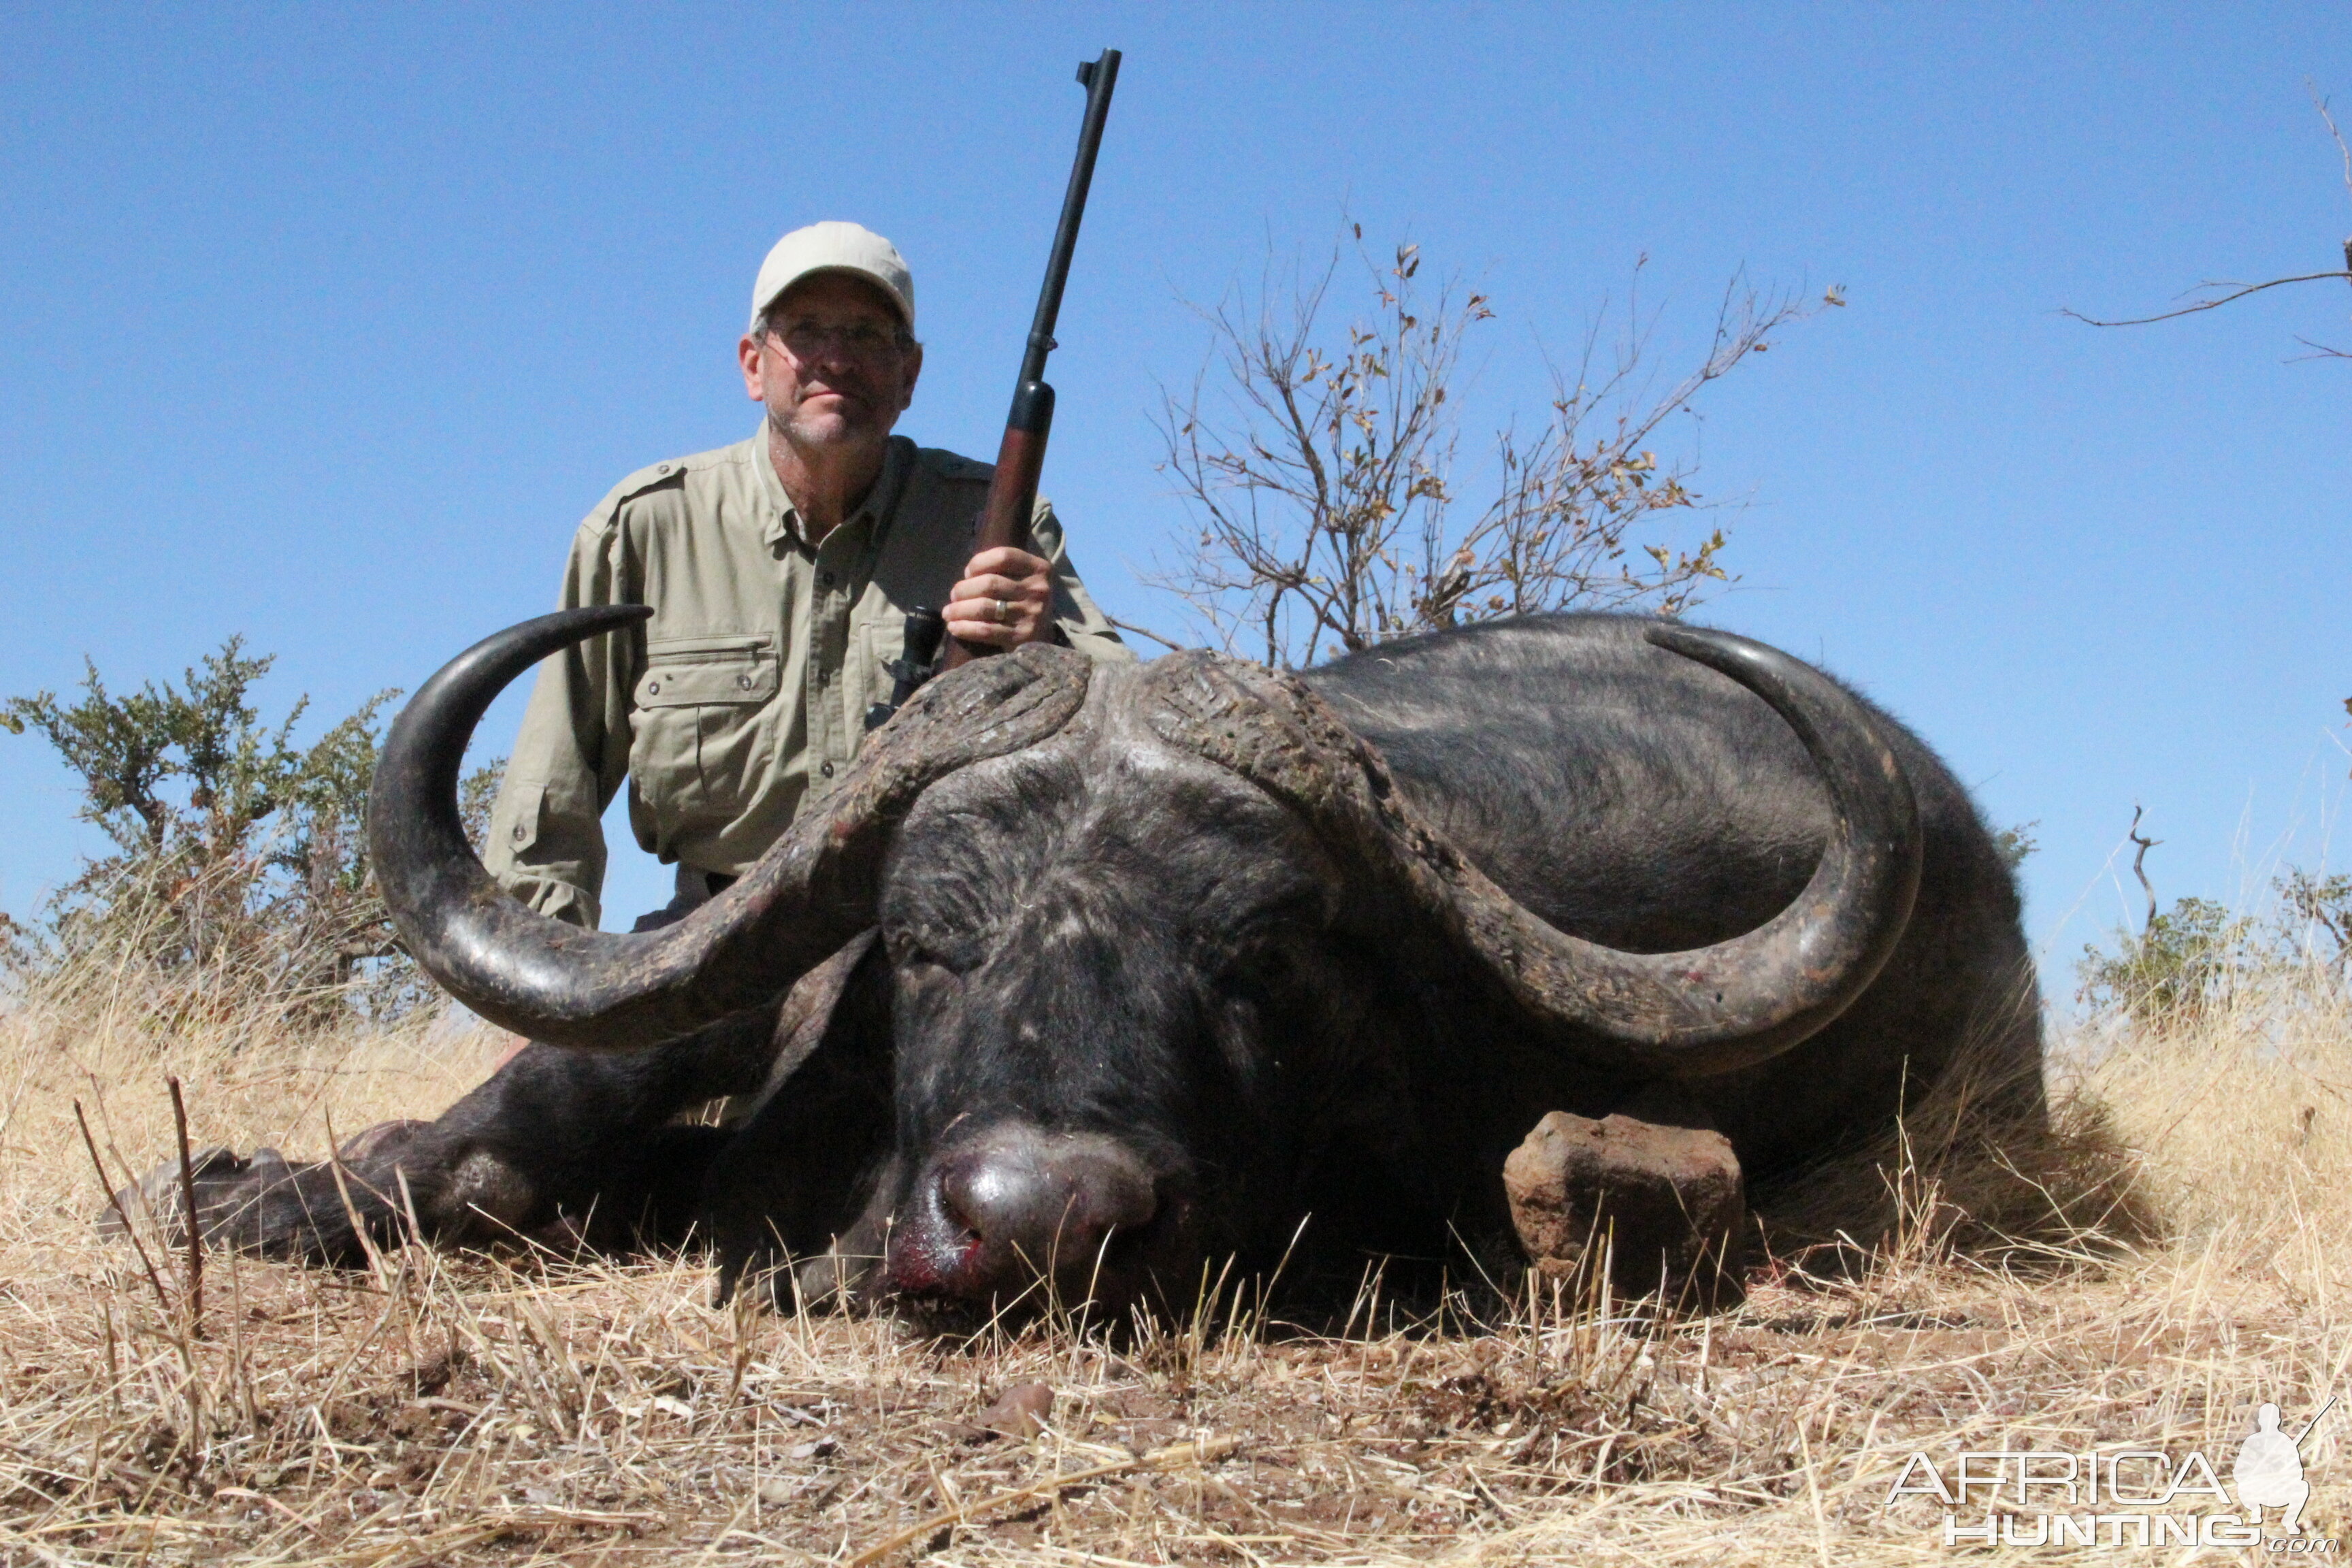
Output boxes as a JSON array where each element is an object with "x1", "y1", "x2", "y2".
[{"x1": 1148, "y1": 625, "x2": 1922, "y2": 1077}]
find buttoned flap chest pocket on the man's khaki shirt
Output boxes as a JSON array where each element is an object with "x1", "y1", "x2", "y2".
[{"x1": 628, "y1": 632, "x2": 783, "y2": 823}]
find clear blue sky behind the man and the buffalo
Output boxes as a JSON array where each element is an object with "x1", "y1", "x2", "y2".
[{"x1": 0, "y1": 2, "x2": 2352, "y2": 994}]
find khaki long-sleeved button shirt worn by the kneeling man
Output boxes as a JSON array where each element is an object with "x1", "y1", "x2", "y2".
[{"x1": 485, "y1": 425, "x2": 1134, "y2": 926}]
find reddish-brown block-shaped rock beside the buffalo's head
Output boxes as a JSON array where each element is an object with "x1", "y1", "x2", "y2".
[{"x1": 1503, "y1": 1109, "x2": 1748, "y2": 1309}]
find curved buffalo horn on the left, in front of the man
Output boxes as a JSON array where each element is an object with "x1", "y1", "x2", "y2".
[{"x1": 367, "y1": 604, "x2": 1087, "y2": 1049}]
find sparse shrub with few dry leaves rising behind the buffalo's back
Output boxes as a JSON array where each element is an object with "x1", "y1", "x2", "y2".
[{"x1": 1145, "y1": 226, "x2": 1844, "y2": 668}]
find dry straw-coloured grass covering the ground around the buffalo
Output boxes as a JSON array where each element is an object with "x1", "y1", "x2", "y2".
[{"x1": 0, "y1": 964, "x2": 2352, "y2": 1568}]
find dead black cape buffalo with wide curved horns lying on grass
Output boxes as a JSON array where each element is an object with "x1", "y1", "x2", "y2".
[{"x1": 129, "y1": 606, "x2": 2039, "y2": 1305}]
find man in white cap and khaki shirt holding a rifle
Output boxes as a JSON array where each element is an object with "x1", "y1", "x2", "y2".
[{"x1": 487, "y1": 223, "x2": 1134, "y2": 928}]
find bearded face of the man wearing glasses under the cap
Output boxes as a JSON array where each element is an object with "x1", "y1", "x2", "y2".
[{"x1": 738, "y1": 273, "x2": 922, "y2": 449}]
